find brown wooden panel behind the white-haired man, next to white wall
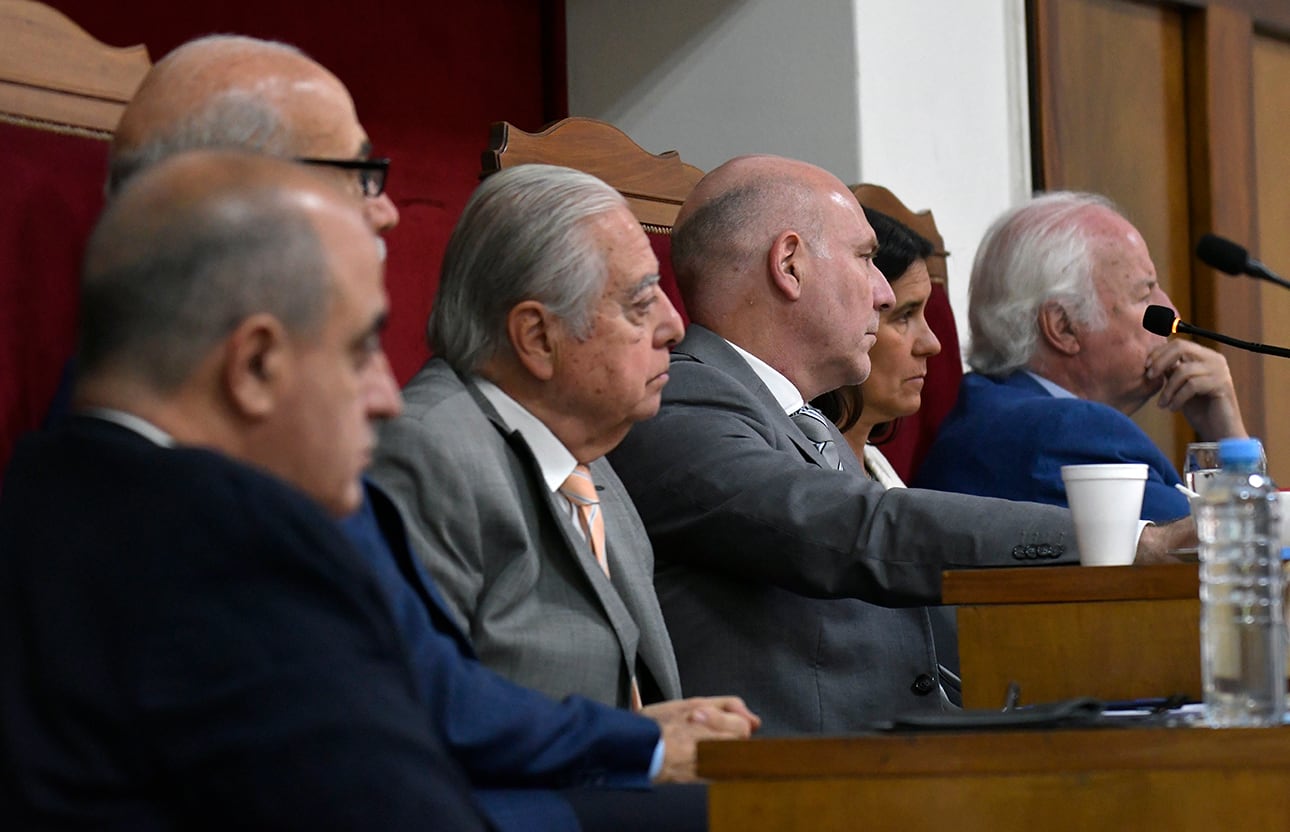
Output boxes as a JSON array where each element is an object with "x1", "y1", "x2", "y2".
[{"x1": 1031, "y1": 0, "x2": 1191, "y2": 462}]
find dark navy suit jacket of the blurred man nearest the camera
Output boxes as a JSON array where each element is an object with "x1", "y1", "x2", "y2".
[{"x1": 0, "y1": 417, "x2": 485, "y2": 832}]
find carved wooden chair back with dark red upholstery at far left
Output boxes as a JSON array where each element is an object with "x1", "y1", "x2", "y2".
[{"x1": 0, "y1": 0, "x2": 151, "y2": 472}]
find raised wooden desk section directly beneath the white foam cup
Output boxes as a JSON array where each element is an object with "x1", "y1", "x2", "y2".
[{"x1": 943, "y1": 564, "x2": 1201, "y2": 708}]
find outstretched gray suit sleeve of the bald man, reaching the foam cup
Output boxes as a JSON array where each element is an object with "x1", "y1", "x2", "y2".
[{"x1": 610, "y1": 344, "x2": 1075, "y2": 606}]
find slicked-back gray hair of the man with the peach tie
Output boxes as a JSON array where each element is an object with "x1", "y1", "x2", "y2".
[{"x1": 426, "y1": 165, "x2": 627, "y2": 373}]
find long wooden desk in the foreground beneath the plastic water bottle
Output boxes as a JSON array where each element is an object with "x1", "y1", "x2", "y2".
[{"x1": 699, "y1": 728, "x2": 1290, "y2": 832}]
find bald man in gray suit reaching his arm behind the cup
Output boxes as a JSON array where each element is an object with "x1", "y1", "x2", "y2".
[{"x1": 610, "y1": 156, "x2": 1195, "y2": 733}]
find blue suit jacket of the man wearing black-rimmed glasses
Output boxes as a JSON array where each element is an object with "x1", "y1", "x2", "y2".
[{"x1": 343, "y1": 484, "x2": 659, "y2": 831}]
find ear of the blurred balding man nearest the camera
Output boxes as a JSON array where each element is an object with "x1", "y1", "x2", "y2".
[{"x1": 222, "y1": 315, "x2": 293, "y2": 419}]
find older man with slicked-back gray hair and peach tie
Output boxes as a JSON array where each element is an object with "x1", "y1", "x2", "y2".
[{"x1": 372, "y1": 165, "x2": 744, "y2": 716}]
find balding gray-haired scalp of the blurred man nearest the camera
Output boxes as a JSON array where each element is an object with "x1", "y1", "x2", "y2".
[{"x1": 77, "y1": 156, "x2": 330, "y2": 393}]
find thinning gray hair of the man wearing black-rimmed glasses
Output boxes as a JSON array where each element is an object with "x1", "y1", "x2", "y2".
[{"x1": 106, "y1": 35, "x2": 308, "y2": 199}]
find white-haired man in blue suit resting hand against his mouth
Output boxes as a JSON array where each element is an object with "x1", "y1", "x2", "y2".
[{"x1": 915, "y1": 192, "x2": 1246, "y2": 521}]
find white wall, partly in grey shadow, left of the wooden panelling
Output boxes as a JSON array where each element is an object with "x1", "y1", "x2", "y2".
[{"x1": 565, "y1": 0, "x2": 1031, "y2": 361}]
